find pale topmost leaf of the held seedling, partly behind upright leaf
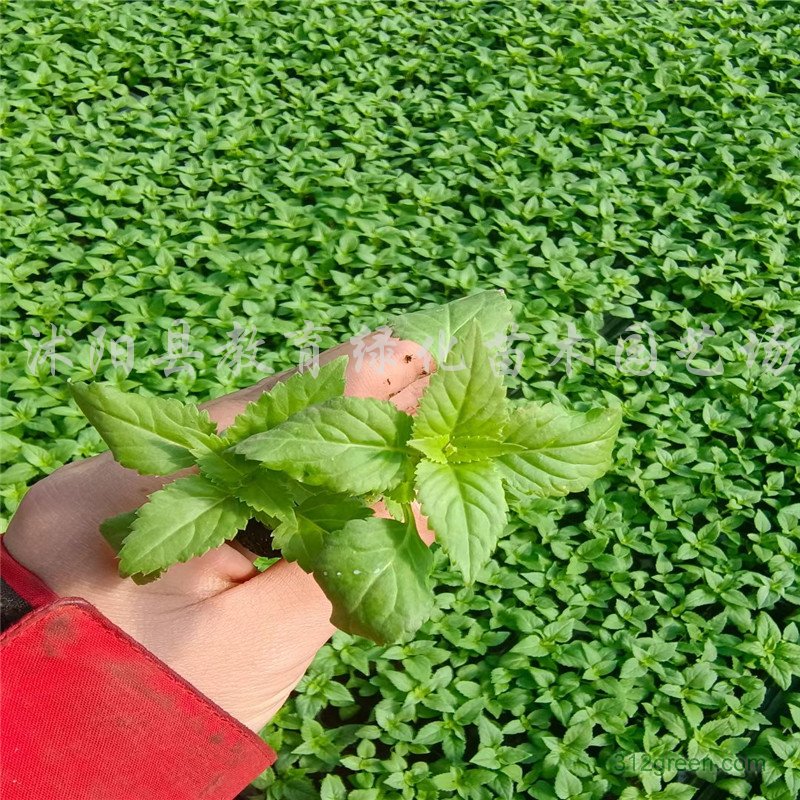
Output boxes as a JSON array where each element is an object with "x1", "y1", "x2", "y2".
[{"x1": 389, "y1": 289, "x2": 513, "y2": 364}]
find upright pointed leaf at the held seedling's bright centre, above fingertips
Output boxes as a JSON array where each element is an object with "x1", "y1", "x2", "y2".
[{"x1": 412, "y1": 322, "x2": 508, "y2": 449}]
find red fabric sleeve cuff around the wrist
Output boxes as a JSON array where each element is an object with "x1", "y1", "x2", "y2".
[{"x1": 0, "y1": 536, "x2": 276, "y2": 800}]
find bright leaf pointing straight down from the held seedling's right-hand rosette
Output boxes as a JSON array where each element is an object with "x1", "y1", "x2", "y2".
[{"x1": 417, "y1": 461, "x2": 507, "y2": 583}]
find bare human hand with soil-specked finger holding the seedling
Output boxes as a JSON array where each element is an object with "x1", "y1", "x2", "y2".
[{"x1": 3, "y1": 334, "x2": 433, "y2": 731}]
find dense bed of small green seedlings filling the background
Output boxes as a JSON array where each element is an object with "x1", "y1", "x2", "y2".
[{"x1": 0, "y1": 0, "x2": 800, "y2": 800}]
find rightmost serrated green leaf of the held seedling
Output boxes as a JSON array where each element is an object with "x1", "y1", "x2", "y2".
[{"x1": 497, "y1": 403, "x2": 621, "y2": 497}]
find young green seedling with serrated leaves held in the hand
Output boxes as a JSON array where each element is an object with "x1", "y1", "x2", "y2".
[{"x1": 73, "y1": 292, "x2": 621, "y2": 642}]
